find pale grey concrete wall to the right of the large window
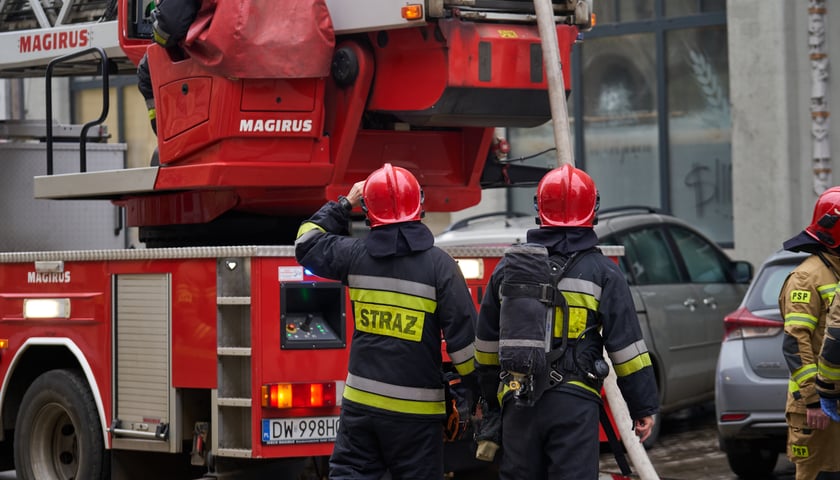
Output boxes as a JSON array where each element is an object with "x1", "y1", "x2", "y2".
[{"x1": 727, "y1": 0, "x2": 840, "y2": 266}]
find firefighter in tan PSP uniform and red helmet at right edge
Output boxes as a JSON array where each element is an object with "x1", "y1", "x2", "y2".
[{"x1": 779, "y1": 187, "x2": 840, "y2": 480}]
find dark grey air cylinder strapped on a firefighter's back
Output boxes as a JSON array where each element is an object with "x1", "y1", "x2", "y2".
[{"x1": 499, "y1": 243, "x2": 552, "y2": 376}]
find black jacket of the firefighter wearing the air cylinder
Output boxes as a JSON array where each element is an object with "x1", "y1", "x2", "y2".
[{"x1": 475, "y1": 228, "x2": 659, "y2": 419}]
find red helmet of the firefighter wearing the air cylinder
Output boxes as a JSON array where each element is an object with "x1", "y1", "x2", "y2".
[{"x1": 534, "y1": 164, "x2": 599, "y2": 227}]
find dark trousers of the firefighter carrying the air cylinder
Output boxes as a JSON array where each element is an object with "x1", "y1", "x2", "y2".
[{"x1": 499, "y1": 389, "x2": 600, "y2": 480}]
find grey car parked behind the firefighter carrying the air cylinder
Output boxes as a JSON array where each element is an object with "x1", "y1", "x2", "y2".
[{"x1": 436, "y1": 207, "x2": 752, "y2": 446}]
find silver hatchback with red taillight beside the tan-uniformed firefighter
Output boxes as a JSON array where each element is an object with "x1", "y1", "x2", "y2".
[{"x1": 715, "y1": 251, "x2": 807, "y2": 478}]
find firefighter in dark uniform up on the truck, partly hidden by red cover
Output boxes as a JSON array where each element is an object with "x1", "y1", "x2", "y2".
[{"x1": 137, "y1": 0, "x2": 201, "y2": 135}]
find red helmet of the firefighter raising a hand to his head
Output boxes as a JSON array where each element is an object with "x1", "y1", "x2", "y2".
[{"x1": 362, "y1": 163, "x2": 423, "y2": 228}]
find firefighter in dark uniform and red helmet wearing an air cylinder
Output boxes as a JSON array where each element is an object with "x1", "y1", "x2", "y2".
[{"x1": 475, "y1": 165, "x2": 659, "y2": 480}]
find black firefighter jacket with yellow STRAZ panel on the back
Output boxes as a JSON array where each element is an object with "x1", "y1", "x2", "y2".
[{"x1": 295, "y1": 202, "x2": 478, "y2": 420}]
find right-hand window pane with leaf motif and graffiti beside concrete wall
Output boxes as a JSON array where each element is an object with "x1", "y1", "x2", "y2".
[{"x1": 665, "y1": 26, "x2": 733, "y2": 243}]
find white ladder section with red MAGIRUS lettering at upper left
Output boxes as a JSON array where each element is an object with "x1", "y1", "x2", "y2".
[{"x1": 0, "y1": 0, "x2": 135, "y2": 78}]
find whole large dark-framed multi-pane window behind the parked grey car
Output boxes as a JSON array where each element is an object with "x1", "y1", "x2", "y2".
[{"x1": 508, "y1": 0, "x2": 733, "y2": 247}]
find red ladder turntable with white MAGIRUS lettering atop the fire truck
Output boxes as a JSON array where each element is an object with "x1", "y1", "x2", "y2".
[{"x1": 0, "y1": 0, "x2": 591, "y2": 245}]
